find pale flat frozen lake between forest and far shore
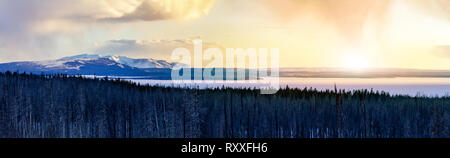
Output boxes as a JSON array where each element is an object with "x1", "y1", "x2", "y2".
[{"x1": 122, "y1": 77, "x2": 450, "y2": 96}]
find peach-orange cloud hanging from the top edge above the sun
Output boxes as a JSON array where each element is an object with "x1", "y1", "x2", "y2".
[{"x1": 262, "y1": 0, "x2": 390, "y2": 41}]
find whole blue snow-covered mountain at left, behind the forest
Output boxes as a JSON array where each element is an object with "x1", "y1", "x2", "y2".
[{"x1": 0, "y1": 54, "x2": 176, "y2": 78}]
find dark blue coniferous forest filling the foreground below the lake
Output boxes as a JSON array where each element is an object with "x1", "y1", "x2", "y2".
[{"x1": 0, "y1": 72, "x2": 450, "y2": 138}]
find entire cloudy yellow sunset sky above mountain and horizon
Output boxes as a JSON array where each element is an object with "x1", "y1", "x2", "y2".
[{"x1": 0, "y1": 0, "x2": 450, "y2": 70}]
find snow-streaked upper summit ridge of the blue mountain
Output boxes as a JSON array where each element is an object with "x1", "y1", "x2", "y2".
[{"x1": 61, "y1": 54, "x2": 176, "y2": 68}]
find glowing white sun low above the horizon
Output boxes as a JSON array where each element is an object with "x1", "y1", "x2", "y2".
[{"x1": 341, "y1": 52, "x2": 369, "y2": 70}]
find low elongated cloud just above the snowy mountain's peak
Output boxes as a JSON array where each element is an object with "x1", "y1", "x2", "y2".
[{"x1": 93, "y1": 39, "x2": 223, "y2": 59}]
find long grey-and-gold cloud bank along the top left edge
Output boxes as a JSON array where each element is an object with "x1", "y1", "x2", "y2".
[{"x1": 0, "y1": 0, "x2": 215, "y2": 33}]
